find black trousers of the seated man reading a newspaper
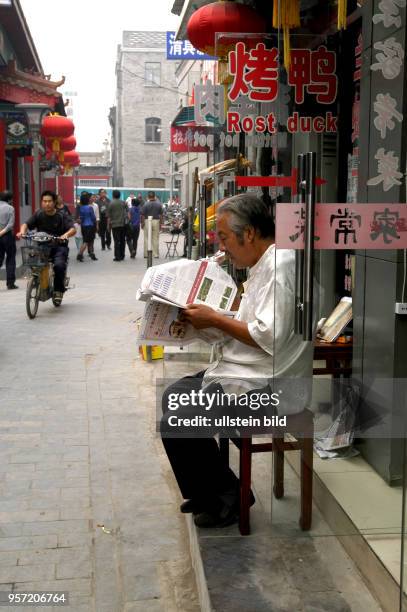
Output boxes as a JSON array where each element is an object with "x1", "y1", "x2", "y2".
[{"x1": 160, "y1": 372, "x2": 239, "y2": 511}]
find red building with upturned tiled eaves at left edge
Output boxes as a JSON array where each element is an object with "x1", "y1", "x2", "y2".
[{"x1": 0, "y1": 0, "x2": 65, "y2": 228}]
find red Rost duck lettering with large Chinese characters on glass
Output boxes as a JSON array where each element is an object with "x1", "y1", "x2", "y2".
[{"x1": 195, "y1": 41, "x2": 338, "y2": 135}]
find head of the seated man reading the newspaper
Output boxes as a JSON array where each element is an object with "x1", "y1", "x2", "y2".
[{"x1": 216, "y1": 193, "x2": 275, "y2": 268}]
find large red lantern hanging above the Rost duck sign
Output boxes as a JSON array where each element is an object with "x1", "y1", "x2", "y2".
[{"x1": 187, "y1": 0, "x2": 266, "y2": 56}]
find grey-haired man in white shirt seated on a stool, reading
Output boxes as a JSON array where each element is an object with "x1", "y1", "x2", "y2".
[{"x1": 160, "y1": 194, "x2": 312, "y2": 527}]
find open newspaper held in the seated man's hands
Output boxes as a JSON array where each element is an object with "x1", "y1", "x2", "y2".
[{"x1": 137, "y1": 259, "x2": 237, "y2": 346}]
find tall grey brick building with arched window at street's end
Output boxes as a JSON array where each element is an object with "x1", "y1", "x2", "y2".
[{"x1": 109, "y1": 31, "x2": 178, "y2": 189}]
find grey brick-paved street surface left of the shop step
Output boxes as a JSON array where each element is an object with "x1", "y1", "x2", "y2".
[{"x1": 0, "y1": 238, "x2": 199, "y2": 612}]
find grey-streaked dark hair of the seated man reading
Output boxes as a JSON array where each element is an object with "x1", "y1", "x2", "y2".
[{"x1": 217, "y1": 193, "x2": 275, "y2": 240}]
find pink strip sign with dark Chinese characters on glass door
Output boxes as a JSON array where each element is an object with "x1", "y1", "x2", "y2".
[{"x1": 276, "y1": 203, "x2": 407, "y2": 250}]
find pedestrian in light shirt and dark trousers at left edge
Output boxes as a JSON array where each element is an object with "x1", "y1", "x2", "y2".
[{"x1": 0, "y1": 191, "x2": 18, "y2": 289}]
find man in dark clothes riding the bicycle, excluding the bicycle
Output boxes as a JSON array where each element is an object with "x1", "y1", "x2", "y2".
[{"x1": 17, "y1": 191, "x2": 76, "y2": 302}]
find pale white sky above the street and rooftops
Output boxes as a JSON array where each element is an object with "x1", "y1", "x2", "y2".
[{"x1": 20, "y1": 0, "x2": 179, "y2": 151}]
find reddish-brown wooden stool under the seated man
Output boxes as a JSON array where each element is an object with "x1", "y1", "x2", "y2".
[{"x1": 219, "y1": 410, "x2": 314, "y2": 535}]
